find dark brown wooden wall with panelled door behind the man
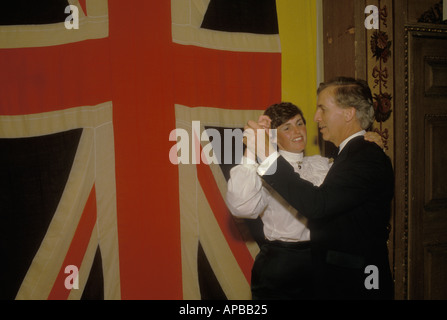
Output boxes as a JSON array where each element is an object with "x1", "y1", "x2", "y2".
[{"x1": 320, "y1": 0, "x2": 447, "y2": 299}]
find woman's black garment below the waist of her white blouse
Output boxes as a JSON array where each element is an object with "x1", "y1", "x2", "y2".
[{"x1": 251, "y1": 241, "x2": 312, "y2": 300}]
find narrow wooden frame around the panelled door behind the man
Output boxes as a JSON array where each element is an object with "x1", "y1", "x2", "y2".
[{"x1": 394, "y1": 18, "x2": 447, "y2": 300}]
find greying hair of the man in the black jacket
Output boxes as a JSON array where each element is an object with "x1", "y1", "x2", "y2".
[{"x1": 317, "y1": 77, "x2": 375, "y2": 130}]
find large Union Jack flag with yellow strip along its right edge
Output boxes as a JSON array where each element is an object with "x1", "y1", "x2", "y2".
[{"x1": 0, "y1": 0, "x2": 315, "y2": 299}]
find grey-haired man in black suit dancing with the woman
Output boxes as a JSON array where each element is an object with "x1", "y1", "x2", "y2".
[{"x1": 246, "y1": 78, "x2": 394, "y2": 299}]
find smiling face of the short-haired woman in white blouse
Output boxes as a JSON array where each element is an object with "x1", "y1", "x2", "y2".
[{"x1": 277, "y1": 114, "x2": 307, "y2": 153}]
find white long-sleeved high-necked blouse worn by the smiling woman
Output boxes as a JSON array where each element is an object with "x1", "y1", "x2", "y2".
[{"x1": 226, "y1": 150, "x2": 332, "y2": 242}]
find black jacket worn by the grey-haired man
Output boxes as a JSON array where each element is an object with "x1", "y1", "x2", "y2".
[{"x1": 263, "y1": 136, "x2": 394, "y2": 298}]
